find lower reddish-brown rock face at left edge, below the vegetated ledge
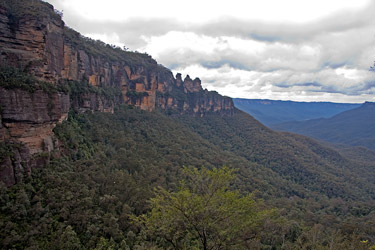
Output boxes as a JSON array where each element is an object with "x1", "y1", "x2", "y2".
[{"x1": 0, "y1": 88, "x2": 70, "y2": 186}]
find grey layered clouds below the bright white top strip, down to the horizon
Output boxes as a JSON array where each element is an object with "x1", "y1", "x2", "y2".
[{"x1": 49, "y1": 0, "x2": 375, "y2": 102}]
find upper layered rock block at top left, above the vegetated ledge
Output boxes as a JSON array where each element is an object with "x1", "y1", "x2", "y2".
[{"x1": 0, "y1": 4, "x2": 64, "y2": 81}]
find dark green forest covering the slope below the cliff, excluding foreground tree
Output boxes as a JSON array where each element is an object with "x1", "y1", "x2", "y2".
[{"x1": 0, "y1": 106, "x2": 375, "y2": 249}]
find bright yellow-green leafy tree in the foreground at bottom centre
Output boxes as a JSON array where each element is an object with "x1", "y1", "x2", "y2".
[{"x1": 137, "y1": 167, "x2": 269, "y2": 249}]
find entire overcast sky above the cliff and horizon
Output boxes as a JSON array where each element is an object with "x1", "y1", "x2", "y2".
[{"x1": 47, "y1": 0, "x2": 375, "y2": 102}]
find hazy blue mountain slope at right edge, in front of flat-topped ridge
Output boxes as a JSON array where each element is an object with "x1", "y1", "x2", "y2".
[{"x1": 272, "y1": 102, "x2": 375, "y2": 149}]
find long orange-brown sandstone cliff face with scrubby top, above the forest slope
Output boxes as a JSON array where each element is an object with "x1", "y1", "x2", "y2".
[{"x1": 0, "y1": 0, "x2": 234, "y2": 184}]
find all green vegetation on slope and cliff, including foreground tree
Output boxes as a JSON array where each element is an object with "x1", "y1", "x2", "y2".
[{"x1": 0, "y1": 0, "x2": 375, "y2": 250}]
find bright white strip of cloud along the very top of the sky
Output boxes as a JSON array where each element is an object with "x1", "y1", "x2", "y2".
[{"x1": 47, "y1": 0, "x2": 369, "y2": 23}]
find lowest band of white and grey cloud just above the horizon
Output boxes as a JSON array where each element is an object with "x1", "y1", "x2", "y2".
[{"x1": 174, "y1": 65, "x2": 375, "y2": 102}]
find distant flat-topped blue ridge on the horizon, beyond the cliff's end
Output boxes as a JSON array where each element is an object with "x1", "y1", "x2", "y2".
[{"x1": 233, "y1": 98, "x2": 361, "y2": 126}]
